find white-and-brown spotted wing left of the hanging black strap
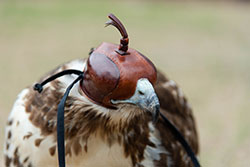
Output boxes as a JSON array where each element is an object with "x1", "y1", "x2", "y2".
[{"x1": 4, "y1": 60, "x2": 85, "y2": 167}]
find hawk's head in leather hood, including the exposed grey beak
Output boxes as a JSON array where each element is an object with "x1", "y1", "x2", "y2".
[{"x1": 80, "y1": 14, "x2": 159, "y2": 121}]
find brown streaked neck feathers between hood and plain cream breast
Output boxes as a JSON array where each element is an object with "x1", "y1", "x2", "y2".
[{"x1": 62, "y1": 97, "x2": 152, "y2": 165}]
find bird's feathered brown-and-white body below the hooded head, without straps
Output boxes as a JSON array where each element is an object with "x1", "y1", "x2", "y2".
[{"x1": 4, "y1": 60, "x2": 198, "y2": 167}]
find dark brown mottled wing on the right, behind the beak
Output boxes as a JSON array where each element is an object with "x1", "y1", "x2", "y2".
[{"x1": 155, "y1": 71, "x2": 199, "y2": 166}]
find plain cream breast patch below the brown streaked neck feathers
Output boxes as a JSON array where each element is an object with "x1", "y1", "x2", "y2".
[{"x1": 66, "y1": 137, "x2": 132, "y2": 167}]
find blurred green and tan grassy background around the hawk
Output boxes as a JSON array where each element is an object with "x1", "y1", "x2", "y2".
[{"x1": 0, "y1": 0, "x2": 250, "y2": 167}]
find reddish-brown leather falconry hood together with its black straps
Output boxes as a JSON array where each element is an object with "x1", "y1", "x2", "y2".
[{"x1": 34, "y1": 14, "x2": 200, "y2": 167}]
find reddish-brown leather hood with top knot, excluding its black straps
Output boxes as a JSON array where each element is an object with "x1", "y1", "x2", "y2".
[{"x1": 80, "y1": 14, "x2": 157, "y2": 108}]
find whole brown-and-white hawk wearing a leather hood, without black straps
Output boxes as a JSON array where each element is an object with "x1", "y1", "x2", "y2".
[{"x1": 4, "y1": 15, "x2": 199, "y2": 167}]
